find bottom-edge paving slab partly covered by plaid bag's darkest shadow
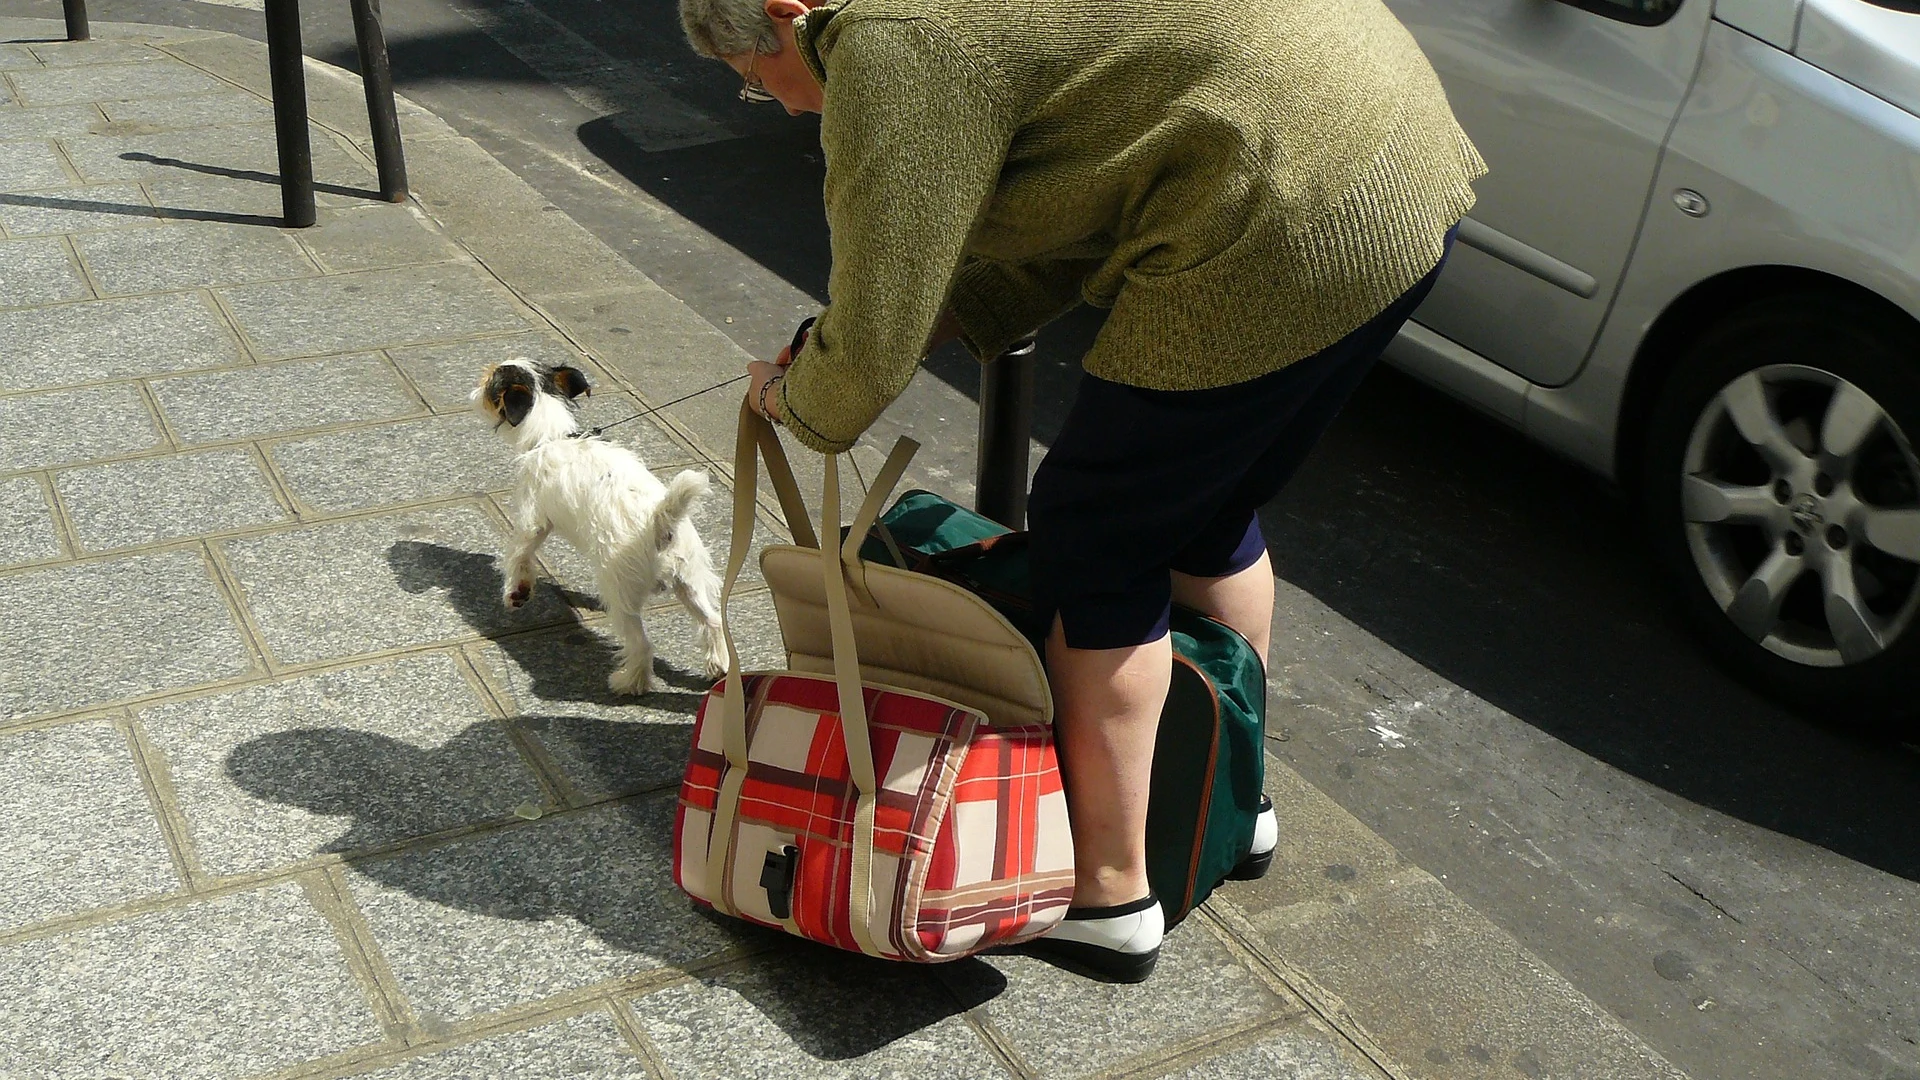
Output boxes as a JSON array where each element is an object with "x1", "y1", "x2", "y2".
[{"x1": 632, "y1": 942, "x2": 1008, "y2": 1080}]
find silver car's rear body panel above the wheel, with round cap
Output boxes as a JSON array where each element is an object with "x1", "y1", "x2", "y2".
[{"x1": 1520, "y1": 16, "x2": 1920, "y2": 477}]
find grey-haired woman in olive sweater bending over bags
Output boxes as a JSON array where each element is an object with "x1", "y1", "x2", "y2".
[{"x1": 680, "y1": 0, "x2": 1484, "y2": 980}]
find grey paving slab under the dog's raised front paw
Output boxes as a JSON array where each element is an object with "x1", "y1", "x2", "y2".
[{"x1": 221, "y1": 505, "x2": 574, "y2": 663}]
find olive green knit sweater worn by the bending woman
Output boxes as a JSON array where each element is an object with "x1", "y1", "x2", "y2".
[{"x1": 780, "y1": 0, "x2": 1486, "y2": 452}]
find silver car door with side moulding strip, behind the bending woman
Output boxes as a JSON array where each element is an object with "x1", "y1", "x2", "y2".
[{"x1": 1386, "y1": 0, "x2": 1720, "y2": 386}]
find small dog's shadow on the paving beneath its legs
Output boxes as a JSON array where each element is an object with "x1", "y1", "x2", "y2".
[{"x1": 386, "y1": 540, "x2": 712, "y2": 717}]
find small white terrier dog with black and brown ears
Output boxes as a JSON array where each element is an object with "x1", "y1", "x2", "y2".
[{"x1": 472, "y1": 359, "x2": 726, "y2": 694}]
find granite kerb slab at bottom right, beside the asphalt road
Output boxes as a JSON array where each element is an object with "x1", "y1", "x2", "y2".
[{"x1": 1258, "y1": 871, "x2": 1684, "y2": 1080}]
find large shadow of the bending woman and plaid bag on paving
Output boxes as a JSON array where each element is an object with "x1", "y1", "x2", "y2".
[{"x1": 227, "y1": 715, "x2": 1006, "y2": 1061}]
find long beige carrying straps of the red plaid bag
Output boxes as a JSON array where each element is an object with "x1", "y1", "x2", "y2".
[{"x1": 707, "y1": 402, "x2": 920, "y2": 957}]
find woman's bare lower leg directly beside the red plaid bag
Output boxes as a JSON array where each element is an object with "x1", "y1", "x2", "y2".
[{"x1": 1046, "y1": 619, "x2": 1173, "y2": 907}]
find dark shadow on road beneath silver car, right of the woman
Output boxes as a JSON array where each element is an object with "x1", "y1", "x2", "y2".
[{"x1": 1261, "y1": 369, "x2": 1920, "y2": 880}]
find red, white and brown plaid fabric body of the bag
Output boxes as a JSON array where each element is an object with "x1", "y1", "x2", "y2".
[{"x1": 674, "y1": 673, "x2": 1073, "y2": 961}]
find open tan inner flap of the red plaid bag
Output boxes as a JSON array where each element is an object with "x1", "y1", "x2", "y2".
[{"x1": 760, "y1": 546, "x2": 1054, "y2": 724}]
